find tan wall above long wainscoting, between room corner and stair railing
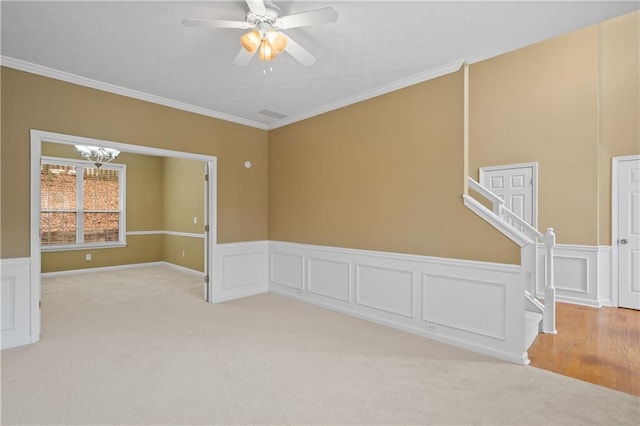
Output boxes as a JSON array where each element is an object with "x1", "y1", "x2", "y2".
[{"x1": 269, "y1": 72, "x2": 519, "y2": 262}]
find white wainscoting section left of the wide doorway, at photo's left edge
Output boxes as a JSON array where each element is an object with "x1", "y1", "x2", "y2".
[{"x1": 0, "y1": 258, "x2": 32, "y2": 349}]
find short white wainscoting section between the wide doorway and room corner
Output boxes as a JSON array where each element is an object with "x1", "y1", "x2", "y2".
[{"x1": 211, "y1": 241, "x2": 269, "y2": 302}]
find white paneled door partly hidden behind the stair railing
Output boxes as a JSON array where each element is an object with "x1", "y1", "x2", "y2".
[{"x1": 480, "y1": 163, "x2": 538, "y2": 228}]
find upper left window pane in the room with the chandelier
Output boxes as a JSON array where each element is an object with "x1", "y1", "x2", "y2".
[{"x1": 40, "y1": 164, "x2": 76, "y2": 210}]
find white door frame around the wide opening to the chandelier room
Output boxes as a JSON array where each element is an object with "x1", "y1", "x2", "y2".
[{"x1": 29, "y1": 129, "x2": 218, "y2": 343}]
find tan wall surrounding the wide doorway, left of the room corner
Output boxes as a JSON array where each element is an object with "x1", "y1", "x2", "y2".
[{"x1": 1, "y1": 67, "x2": 268, "y2": 258}]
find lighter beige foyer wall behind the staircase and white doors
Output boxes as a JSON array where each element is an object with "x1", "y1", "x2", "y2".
[{"x1": 469, "y1": 12, "x2": 640, "y2": 245}]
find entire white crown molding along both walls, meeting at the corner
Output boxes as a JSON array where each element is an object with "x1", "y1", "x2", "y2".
[{"x1": 0, "y1": 56, "x2": 465, "y2": 130}]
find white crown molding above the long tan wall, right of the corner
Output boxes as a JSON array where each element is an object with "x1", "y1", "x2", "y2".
[{"x1": 269, "y1": 59, "x2": 465, "y2": 130}]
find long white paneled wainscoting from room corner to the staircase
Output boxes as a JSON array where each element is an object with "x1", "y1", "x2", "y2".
[{"x1": 269, "y1": 241, "x2": 528, "y2": 364}]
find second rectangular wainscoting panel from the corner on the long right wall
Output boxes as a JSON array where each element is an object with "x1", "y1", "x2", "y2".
[{"x1": 307, "y1": 257, "x2": 351, "y2": 302}]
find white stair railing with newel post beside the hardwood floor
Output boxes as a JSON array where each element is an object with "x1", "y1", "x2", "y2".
[{"x1": 463, "y1": 177, "x2": 556, "y2": 334}]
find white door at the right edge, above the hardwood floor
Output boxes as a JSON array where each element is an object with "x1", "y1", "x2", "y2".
[{"x1": 613, "y1": 158, "x2": 640, "y2": 309}]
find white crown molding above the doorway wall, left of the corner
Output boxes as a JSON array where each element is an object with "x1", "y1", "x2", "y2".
[{"x1": 0, "y1": 56, "x2": 269, "y2": 130}]
